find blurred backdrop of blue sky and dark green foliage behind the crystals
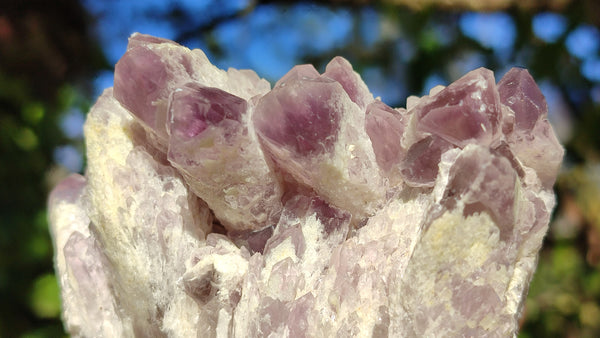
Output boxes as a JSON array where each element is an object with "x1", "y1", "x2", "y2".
[{"x1": 0, "y1": 0, "x2": 600, "y2": 337}]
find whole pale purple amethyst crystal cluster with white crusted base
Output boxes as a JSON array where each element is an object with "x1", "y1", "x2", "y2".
[{"x1": 49, "y1": 34, "x2": 563, "y2": 337}]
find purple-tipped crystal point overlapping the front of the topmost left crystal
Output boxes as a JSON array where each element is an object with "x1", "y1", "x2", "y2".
[{"x1": 168, "y1": 83, "x2": 282, "y2": 231}]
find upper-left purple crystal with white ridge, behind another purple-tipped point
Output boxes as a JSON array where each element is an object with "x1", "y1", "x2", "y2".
[{"x1": 114, "y1": 33, "x2": 269, "y2": 149}]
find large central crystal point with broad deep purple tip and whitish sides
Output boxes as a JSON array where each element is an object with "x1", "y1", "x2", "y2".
[{"x1": 252, "y1": 68, "x2": 384, "y2": 220}]
